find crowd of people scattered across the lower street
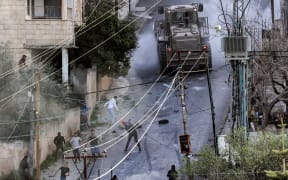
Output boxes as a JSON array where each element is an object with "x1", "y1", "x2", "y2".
[{"x1": 15, "y1": 93, "x2": 178, "y2": 180}]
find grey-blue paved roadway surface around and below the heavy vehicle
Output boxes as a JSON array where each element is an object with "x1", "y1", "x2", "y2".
[{"x1": 88, "y1": 0, "x2": 230, "y2": 180}]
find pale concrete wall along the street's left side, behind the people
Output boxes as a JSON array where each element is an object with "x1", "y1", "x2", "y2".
[{"x1": 0, "y1": 108, "x2": 80, "y2": 173}]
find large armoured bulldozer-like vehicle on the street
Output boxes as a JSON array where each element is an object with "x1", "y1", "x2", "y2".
[{"x1": 154, "y1": 3, "x2": 212, "y2": 73}]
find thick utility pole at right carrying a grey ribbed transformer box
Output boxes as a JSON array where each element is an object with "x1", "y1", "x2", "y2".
[{"x1": 223, "y1": 0, "x2": 251, "y2": 135}]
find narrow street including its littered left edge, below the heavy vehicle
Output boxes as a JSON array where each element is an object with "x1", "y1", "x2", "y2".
[{"x1": 39, "y1": 0, "x2": 231, "y2": 180}]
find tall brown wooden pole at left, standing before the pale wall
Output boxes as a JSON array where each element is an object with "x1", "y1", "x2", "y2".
[{"x1": 34, "y1": 69, "x2": 41, "y2": 180}]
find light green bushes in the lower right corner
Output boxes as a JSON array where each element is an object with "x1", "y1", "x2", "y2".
[{"x1": 181, "y1": 130, "x2": 281, "y2": 180}]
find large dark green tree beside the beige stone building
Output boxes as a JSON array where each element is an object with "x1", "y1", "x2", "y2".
[{"x1": 76, "y1": 0, "x2": 137, "y2": 77}]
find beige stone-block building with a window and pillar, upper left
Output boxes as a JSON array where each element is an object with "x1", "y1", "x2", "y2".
[{"x1": 0, "y1": 0, "x2": 83, "y2": 83}]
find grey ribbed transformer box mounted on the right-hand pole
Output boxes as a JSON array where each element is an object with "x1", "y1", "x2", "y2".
[{"x1": 221, "y1": 36, "x2": 251, "y2": 56}]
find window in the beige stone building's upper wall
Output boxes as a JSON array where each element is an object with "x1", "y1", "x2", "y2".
[{"x1": 28, "y1": 0, "x2": 61, "y2": 19}]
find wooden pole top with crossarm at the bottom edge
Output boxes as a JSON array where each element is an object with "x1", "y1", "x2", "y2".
[{"x1": 64, "y1": 151, "x2": 107, "y2": 180}]
